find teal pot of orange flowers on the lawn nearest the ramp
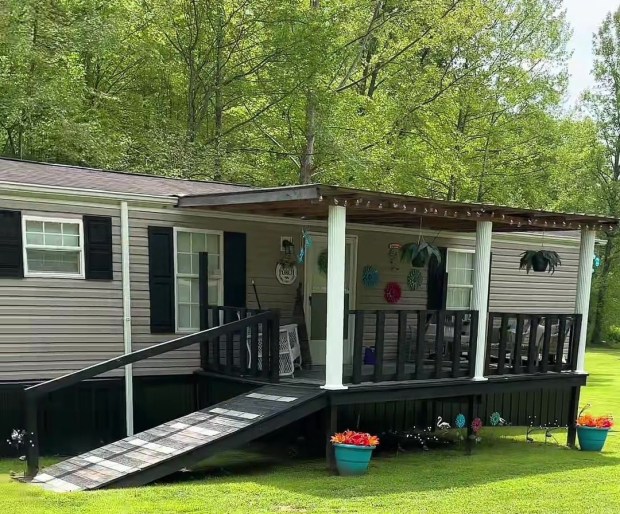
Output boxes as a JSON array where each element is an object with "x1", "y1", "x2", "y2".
[{"x1": 331, "y1": 430, "x2": 379, "y2": 476}]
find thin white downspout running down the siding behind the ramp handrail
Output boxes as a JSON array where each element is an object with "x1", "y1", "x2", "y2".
[{"x1": 121, "y1": 201, "x2": 134, "y2": 436}]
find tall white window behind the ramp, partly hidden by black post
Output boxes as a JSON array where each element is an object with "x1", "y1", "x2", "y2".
[{"x1": 174, "y1": 229, "x2": 223, "y2": 332}]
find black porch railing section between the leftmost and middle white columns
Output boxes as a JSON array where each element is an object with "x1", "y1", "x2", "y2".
[{"x1": 344, "y1": 310, "x2": 478, "y2": 384}]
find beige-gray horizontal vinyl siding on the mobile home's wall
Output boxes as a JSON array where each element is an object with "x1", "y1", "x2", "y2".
[{"x1": 0, "y1": 190, "x2": 578, "y2": 381}]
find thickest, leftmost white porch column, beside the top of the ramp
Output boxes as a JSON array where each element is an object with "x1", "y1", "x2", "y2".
[{"x1": 323, "y1": 205, "x2": 347, "y2": 389}]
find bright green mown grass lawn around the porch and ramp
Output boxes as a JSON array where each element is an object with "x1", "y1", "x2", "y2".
[{"x1": 0, "y1": 350, "x2": 620, "y2": 514}]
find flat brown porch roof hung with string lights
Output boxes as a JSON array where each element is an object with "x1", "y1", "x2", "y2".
[{"x1": 177, "y1": 184, "x2": 619, "y2": 232}]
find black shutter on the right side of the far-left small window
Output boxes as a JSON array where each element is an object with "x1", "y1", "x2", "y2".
[{"x1": 84, "y1": 216, "x2": 114, "y2": 280}]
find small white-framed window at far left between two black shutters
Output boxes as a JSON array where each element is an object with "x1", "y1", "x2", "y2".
[{"x1": 22, "y1": 216, "x2": 84, "y2": 278}]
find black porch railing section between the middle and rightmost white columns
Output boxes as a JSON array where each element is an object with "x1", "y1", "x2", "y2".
[{"x1": 485, "y1": 312, "x2": 581, "y2": 375}]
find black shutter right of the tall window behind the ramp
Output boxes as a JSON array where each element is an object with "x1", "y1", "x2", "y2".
[{"x1": 224, "y1": 232, "x2": 246, "y2": 307}]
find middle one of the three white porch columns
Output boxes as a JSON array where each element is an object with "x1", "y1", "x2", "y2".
[{"x1": 470, "y1": 221, "x2": 493, "y2": 380}]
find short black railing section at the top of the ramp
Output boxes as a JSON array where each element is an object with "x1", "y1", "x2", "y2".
[{"x1": 200, "y1": 305, "x2": 280, "y2": 382}]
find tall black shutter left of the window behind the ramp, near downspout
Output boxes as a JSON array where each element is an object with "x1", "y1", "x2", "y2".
[{"x1": 149, "y1": 227, "x2": 176, "y2": 334}]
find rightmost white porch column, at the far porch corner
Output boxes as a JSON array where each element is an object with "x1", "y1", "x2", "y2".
[{"x1": 575, "y1": 228, "x2": 595, "y2": 373}]
